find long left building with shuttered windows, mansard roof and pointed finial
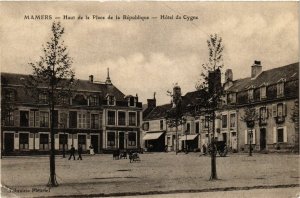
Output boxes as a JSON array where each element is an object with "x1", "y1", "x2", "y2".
[{"x1": 1, "y1": 73, "x2": 142, "y2": 155}]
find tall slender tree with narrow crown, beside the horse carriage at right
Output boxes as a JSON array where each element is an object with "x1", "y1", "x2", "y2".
[{"x1": 196, "y1": 34, "x2": 224, "y2": 180}]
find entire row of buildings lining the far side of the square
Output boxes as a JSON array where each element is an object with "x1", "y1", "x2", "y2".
[{"x1": 1, "y1": 61, "x2": 299, "y2": 155}]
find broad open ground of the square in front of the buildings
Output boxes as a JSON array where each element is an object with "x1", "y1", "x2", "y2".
[{"x1": 1, "y1": 153, "x2": 299, "y2": 197}]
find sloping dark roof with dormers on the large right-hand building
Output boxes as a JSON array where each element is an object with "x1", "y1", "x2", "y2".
[{"x1": 227, "y1": 63, "x2": 299, "y2": 92}]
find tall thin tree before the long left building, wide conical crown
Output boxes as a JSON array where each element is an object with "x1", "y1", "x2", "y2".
[{"x1": 26, "y1": 22, "x2": 76, "y2": 187}]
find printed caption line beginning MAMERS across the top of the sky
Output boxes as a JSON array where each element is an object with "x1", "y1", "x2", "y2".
[{"x1": 24, "y1": 15, "x2": 198, "y2": 21}]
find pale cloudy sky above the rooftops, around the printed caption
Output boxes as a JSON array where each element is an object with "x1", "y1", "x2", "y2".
[{"x1": 0, "y1": 2, "x2": 299, "y2": 104}]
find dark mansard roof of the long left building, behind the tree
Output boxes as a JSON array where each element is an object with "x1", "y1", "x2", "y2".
[{"x1": 1, "y1": 73, "x2": 125, "y2": 102}]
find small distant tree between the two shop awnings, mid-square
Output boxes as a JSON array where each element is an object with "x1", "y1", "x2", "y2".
[{"x1": 166, "y1": 84, "x2": 186, "y2": 155}]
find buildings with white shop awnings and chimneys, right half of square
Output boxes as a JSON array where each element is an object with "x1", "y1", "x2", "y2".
[{"x1": 143, "y1": 61, "x2": 299, "y2": 152}]
